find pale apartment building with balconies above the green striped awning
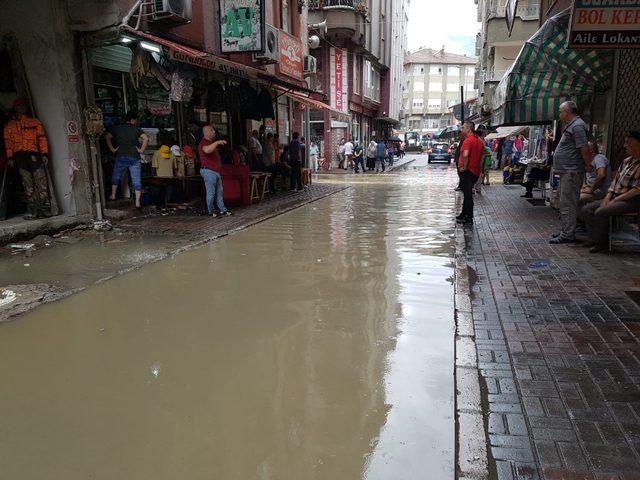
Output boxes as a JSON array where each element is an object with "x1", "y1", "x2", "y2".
[{"x1": 475, "y1": 0, "x2": 540, "y2": 112}]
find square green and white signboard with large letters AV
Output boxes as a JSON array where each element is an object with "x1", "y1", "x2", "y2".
[{"x1": 218, "y1": 0, "x2": 265, "y2": 53}]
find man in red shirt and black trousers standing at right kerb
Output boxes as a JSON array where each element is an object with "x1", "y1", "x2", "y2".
[{"x1": 456, "y1": 122, "x2": 484, "y2": 225}]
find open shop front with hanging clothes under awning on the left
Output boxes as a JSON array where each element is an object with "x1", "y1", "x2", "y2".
[{"x1": 87, "y1": 27, "x2": 326, "y2": 211}]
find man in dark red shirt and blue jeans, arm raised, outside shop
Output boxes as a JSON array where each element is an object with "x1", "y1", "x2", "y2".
[{"x1": 198, "y1": 125, "x2": 231, "y2": 217}]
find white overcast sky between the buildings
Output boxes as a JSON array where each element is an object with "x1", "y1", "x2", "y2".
[{"x1": 408, "y1": 0, "x2": 480, "y2": 56}]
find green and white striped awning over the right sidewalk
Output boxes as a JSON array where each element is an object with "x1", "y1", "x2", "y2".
[{"x1": 491, "y1": 8, "x2": 613, "y2": 125}]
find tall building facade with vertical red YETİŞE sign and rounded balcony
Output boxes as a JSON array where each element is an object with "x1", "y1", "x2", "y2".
[{"x1": 309, "y1": 0, "x2": 408, "y2": 160}]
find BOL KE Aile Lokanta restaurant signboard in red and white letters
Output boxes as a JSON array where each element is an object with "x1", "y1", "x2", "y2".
[{"x1": 569, "y1": 0, "x2": 640, "y2": 49}]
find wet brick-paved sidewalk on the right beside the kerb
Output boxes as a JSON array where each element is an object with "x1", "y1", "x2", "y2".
[{"x1": 459, "y1": 185, "x2": 640, "y2": 480}]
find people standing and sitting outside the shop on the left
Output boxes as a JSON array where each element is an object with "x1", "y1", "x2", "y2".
[{"x1": 106, "y1": 113, "x2": 305, "y2": 217}]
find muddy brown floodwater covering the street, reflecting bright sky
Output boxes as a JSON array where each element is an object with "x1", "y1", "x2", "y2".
[{"x1": 0, "y1": 159, "x2": 457, "y2": 480}]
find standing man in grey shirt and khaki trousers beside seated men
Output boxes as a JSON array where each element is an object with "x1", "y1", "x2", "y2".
[{"x1": 549, "y1": 101, "x2": 593, "y2": 245}]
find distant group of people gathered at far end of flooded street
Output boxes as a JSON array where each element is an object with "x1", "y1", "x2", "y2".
[{"x1": 338, "y1": 139, "x2": 404, "y2": 173}]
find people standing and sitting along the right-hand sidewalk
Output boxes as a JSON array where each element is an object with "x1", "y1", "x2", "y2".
[{"x1": 457, "y1": 101, "x2": 640, "y2": 253}]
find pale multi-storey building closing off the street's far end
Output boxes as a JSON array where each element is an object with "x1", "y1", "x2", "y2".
[{"x1": 404, "y1": 48, "x2": 477, "y2": 133}]
